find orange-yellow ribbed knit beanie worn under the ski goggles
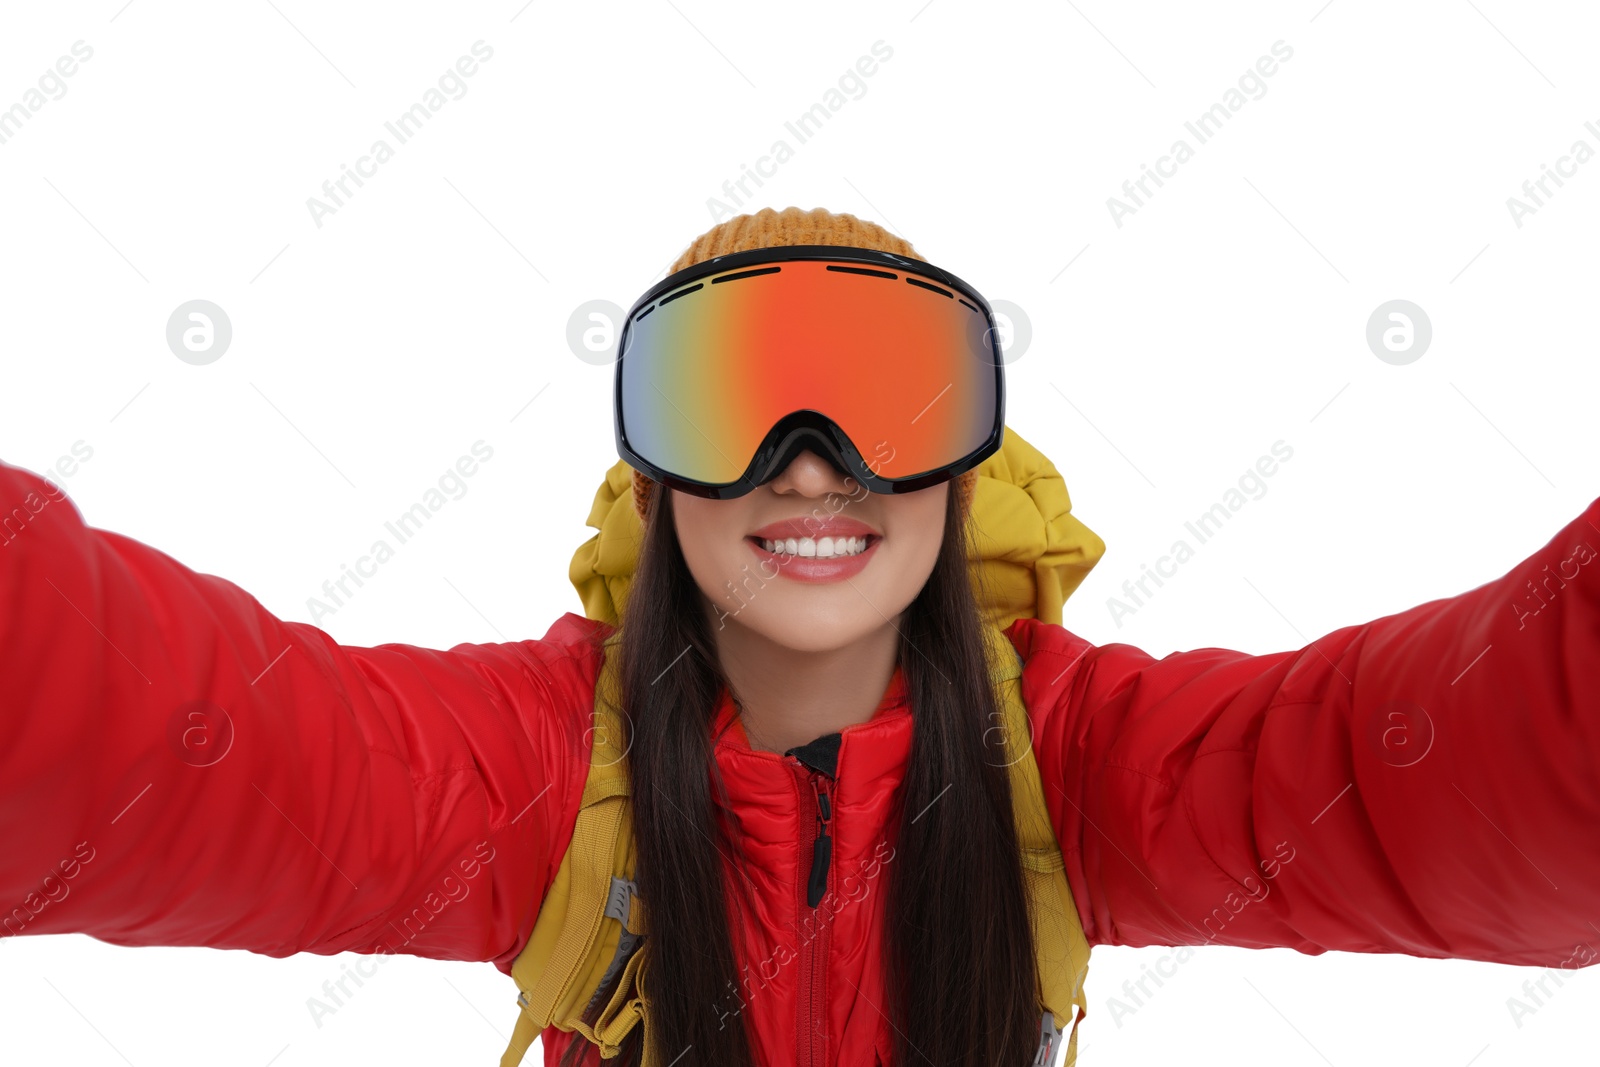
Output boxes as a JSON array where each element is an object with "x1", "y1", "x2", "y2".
[{"x1": 634, "y1": 206, "x2": 978, "y2": 523}]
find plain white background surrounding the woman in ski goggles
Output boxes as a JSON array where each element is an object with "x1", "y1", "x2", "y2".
[{"x1": 0, "y1": 0, "x2": 1600, "y2": 1067}]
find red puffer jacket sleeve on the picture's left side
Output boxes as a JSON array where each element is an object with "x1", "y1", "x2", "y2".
[{"x1": 0, "y1": 464, "x2": 598, "y2": 973}]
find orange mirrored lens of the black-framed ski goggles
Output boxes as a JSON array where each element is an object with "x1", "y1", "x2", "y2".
[{"x1": 619, "y1": 259, "x2": 998, "y2": 485}]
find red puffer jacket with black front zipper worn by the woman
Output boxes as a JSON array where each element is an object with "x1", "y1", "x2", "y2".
[{"x1": 0, "y1": 464, "x2": 1600, "y2": 1067}]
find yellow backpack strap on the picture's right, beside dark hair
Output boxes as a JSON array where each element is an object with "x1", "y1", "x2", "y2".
[{"x1": 986, "y1": 627, "x2": 1090, "y2": 1067}]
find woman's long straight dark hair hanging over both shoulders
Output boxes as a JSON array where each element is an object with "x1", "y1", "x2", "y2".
[{"x1": 562, "y1": 483, "x2": 1040, "y2": 1067}]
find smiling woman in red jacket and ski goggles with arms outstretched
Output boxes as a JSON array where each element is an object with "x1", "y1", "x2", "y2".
[{"x1": 0, "y1": 208, "x2": 1600, "y2": 1065}]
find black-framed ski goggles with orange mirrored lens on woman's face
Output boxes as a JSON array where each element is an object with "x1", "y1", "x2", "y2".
[{"x1": 614, "y1": 245, "x2": 1005, "y2": 499}]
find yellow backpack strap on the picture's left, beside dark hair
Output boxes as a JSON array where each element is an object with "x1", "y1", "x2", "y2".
[{"x1": 501, "y1": 632, "x2": 654, "y2": 1067}]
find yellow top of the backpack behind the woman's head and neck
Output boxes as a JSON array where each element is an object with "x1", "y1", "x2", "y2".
[{"x1": 568, "y1": 427, "x2": 1106, "y2": 629}]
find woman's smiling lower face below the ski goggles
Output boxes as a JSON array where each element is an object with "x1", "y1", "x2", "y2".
[{"x1": 672, "y1": 451, "x2": 950, "y2": 651}]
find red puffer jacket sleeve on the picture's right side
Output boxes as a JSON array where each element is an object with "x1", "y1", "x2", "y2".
[{"x1": 1024, "y1": 501, "x2": 1600, "y2": 966}]
